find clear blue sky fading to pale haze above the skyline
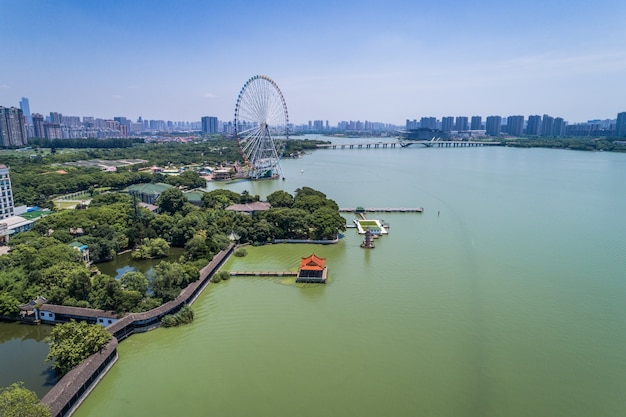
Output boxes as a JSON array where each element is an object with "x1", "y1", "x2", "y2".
[{"x1": 0, "y1": 0, "x2": 626, "y2": 126}]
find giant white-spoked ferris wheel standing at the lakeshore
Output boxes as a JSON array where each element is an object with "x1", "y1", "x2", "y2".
[{"x1": 234, "y1": 75, "x2": 289, "y2": 179}]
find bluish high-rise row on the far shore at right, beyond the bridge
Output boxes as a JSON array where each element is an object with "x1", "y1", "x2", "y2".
[{"x1": 405, "y1": 112, "x2": 626, "y2": 138}]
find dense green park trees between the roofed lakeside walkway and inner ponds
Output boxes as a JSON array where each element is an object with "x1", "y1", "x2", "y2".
[{"x1": 0, "y1": 187, "x2": 345, "y2": 315}]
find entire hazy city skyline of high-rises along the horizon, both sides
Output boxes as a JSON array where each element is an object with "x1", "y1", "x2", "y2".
[{"x1": 0, "y1": 97, "x2": 626, "y2": 148}]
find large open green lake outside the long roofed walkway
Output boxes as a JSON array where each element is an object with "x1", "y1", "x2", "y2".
[{"x1": 75, "y1": 144, "x2": 626, "y2": 417}]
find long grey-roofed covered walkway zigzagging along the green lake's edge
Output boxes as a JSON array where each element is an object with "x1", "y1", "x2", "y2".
[{"x1": 41, "y1": 244, "x2": 235, "y2": 417}]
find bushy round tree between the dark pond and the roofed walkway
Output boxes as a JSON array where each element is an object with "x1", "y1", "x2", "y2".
[{"x1": 46, "y1": 320, "x2": 111, "y2": 375}]
